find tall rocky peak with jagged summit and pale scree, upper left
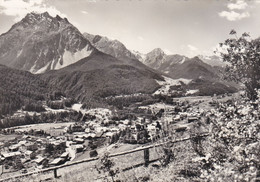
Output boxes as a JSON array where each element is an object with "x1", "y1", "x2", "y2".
[{"x1": 0, "y1": 12, "x2": 95, "y2": 73}]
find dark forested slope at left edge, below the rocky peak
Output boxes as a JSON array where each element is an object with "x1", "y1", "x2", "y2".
[{"x1": 0, "y1": 65, "x2": 62, "y2": 118}]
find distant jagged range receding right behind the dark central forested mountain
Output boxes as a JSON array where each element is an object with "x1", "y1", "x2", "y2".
[{"x1": 84, "y1": 33, "x2": 225, "y2": 80}]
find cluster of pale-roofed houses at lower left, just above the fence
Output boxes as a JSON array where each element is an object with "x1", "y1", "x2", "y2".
[{"x1": 0, "y1": 135, "x2": 69, "y2": 173}]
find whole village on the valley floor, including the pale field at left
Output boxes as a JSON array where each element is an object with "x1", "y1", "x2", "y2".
[{"x1": 0, "y1": 94, "x2": 211, "y2": 177}]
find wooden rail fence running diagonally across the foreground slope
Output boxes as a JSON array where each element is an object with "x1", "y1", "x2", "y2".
[{"x1": 0, "y1": 133, "x2": 209, "y2": 182}]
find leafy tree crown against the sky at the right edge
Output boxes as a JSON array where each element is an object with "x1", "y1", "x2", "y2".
[{"x1": 220, "y1": 30, "x2": 260, "y2": 100}]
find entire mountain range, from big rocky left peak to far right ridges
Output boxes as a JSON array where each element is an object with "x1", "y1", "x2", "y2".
[{"x1": 0, "y1": 13, "x2": 236, "y2": 112}]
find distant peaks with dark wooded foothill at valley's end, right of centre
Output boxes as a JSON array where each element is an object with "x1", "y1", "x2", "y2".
[{"x1": 135, "y1": 48, "x2": 238, "y2": 95}]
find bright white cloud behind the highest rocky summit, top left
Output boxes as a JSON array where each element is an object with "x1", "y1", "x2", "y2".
[{"x1": 0, "y1": 0, "x2": 66, "y2": 21}]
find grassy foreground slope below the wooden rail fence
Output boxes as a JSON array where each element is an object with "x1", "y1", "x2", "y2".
[{"x1": 8, "y1": 141, "x2": 198, "y2": 182}]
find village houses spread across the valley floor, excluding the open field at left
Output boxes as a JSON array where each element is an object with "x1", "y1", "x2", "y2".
[{"x1": 0, "y1": 99, "x2": 207, "y2": 175}]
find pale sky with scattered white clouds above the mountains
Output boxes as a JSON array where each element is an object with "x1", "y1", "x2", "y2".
[{"x1": 0, "y1": 0, "x2": 260, "y2": 57}]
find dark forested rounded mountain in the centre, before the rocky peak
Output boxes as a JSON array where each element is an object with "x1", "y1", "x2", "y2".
[{"x1": 41, "y1": 51, "x2": 163, "y2": 104}]
